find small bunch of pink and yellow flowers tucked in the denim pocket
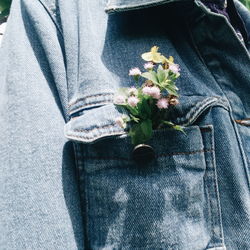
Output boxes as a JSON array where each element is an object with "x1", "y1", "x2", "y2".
[{"x1": 114, "y1": 46, "x2": 182, "y2": 145}]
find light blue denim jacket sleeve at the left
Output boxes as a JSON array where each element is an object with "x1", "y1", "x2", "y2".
[{"x1": 0, "y1": 0, "x2": 83, "y2": 250}]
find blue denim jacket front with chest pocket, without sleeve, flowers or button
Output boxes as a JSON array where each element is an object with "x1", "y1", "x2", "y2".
[{"x1": 62, "y1": 1, "x2": 250, "y2": 249}]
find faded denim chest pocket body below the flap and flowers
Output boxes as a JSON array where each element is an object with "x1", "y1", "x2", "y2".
[{"x1": 64, "y1": 94, "x2": 225, "y2": 250}]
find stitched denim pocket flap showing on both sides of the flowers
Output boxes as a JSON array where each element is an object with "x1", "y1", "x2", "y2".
[{"x1": 65, "y1": 96, "x2": 228, "y2": 143}]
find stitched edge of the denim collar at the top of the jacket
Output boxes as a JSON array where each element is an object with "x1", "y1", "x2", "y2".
[{"x1": 105, "y1": 0, "x2": 192, "y2": 13}]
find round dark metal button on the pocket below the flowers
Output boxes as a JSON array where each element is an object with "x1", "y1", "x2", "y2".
[{"x1": 132, "y1": 144, "x2": 155, "y2": 164}]
